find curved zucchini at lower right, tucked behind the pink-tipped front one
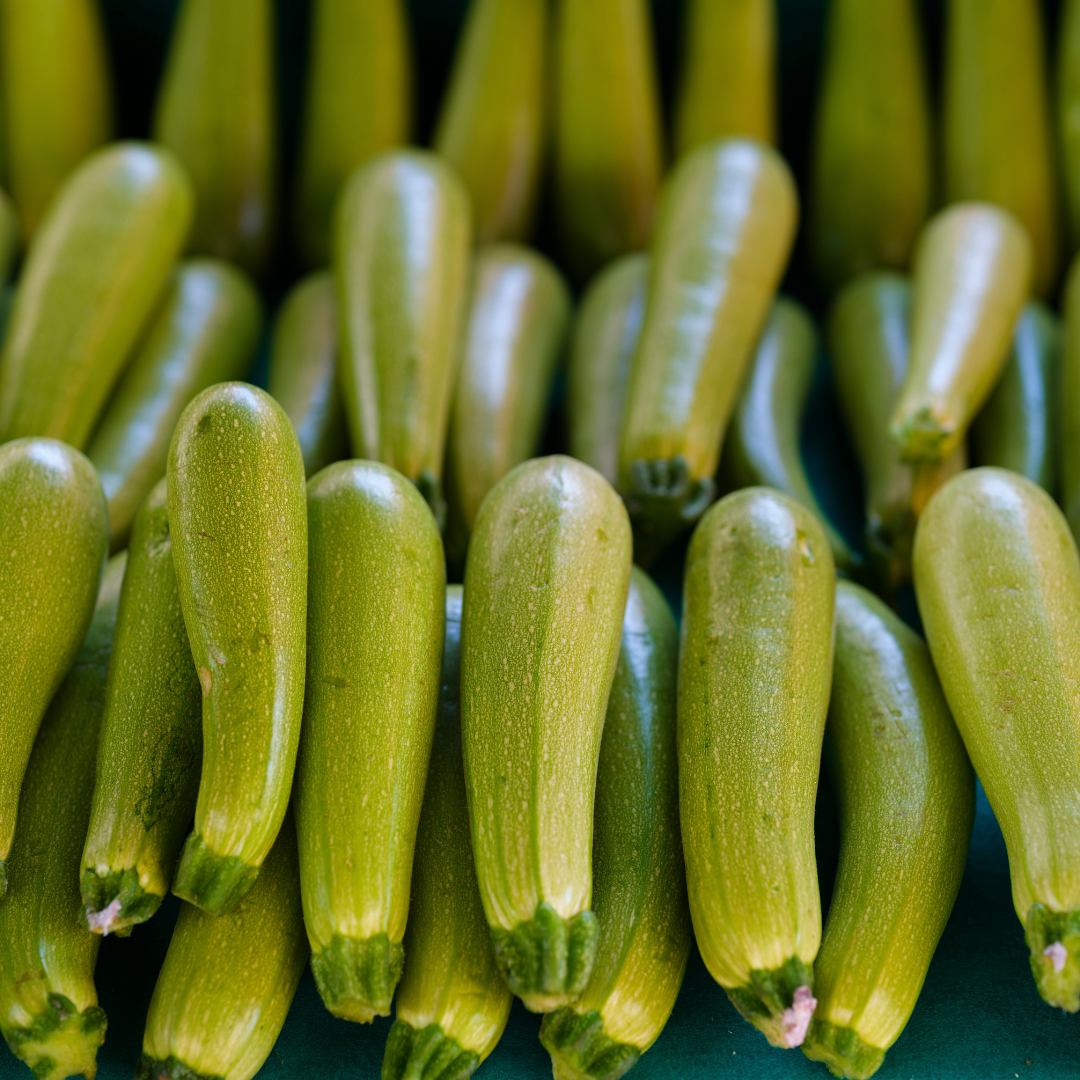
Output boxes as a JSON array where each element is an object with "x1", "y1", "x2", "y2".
[{"x1": 802, "y1": 581, "x2": 975, "y2": 1080}]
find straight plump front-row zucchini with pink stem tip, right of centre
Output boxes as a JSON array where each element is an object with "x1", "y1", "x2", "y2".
[{"x1": 678, "y1": 487, "x2": 835, "y2": 1047}]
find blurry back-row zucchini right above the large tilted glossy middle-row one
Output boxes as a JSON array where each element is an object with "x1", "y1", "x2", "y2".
[{"x1": 675, "y1": 0, "x2": 777, "y2": 157}]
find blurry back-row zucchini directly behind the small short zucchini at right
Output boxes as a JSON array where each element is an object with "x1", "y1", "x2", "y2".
[{"x1": 943, "y1": 0, "x2": 1061, "y2": 298}]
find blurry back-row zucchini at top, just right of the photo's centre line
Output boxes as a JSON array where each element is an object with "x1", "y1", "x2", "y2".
[{"x1": 552, "y1": 0, "x2": 663, "y2": 281}]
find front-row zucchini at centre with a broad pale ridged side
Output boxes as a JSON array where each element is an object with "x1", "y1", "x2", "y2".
[{"x1": 461, "y1": 456, "x2": 631, "y2": 1012}]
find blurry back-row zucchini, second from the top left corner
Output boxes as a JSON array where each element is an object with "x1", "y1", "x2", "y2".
[{"x1": 153, "y1": 0, "x2": 278, "y2": 274}]
